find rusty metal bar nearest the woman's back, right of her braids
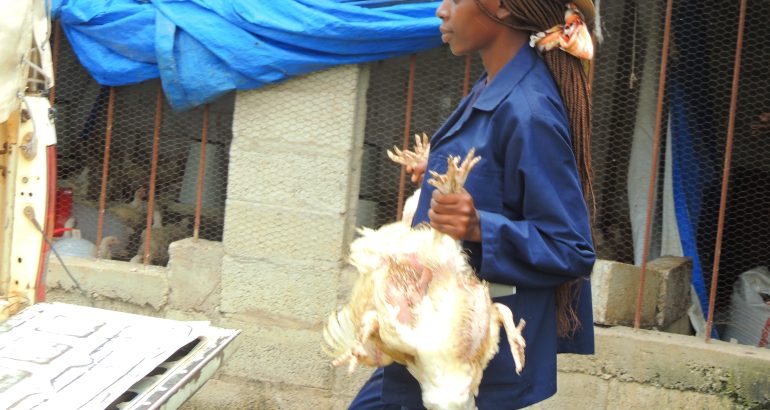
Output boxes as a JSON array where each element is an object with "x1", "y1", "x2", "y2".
[{"x1": 634, "y1": 0, "x2": 674, "y2": 329}]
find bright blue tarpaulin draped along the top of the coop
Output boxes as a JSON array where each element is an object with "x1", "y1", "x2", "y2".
[{"x1": 52, "y1": 0, "x2": 441, "y2": 110}]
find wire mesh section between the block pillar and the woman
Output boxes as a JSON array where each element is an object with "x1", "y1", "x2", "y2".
[{"x1": 358, "y1": 47, "x2": 482, "y2": 231}]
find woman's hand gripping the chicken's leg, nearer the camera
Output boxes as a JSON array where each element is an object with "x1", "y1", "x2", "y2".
[{"x1": 428, "y1": 190, "x2": 481, "y2": 242}]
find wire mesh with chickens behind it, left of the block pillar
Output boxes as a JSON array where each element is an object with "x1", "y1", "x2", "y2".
[{"x1": 54, "y1": 33, "x2": 234, "y2": 265}]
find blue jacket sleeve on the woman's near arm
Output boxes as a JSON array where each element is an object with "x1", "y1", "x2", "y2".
[{"x1": 479, "y1": 116, "x2": 595, "y2": 288}]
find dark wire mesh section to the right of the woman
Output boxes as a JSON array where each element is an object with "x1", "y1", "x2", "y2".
[{"x1": 593, "y1": 1, "x2": 770, "y2": 345}]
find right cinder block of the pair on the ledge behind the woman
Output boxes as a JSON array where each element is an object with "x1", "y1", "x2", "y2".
[{"x1": 647, "y1": 256, "x2": 692, "y2": 326}]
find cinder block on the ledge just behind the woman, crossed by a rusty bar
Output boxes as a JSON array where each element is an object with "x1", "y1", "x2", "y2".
[{"x1": 591, "y1": 259, "x2": 658, "y2": 327}]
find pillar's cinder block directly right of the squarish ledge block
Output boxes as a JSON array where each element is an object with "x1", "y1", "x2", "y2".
[{"x1": 216, "y1": 256, "x2": 341, "y2": 328}]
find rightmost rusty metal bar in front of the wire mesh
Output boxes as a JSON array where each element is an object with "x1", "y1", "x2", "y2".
[{"x1": 706, "y1": 0, "x2": 746, "y2": 342}]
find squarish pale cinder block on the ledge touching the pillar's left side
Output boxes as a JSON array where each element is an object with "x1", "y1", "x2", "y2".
[{"x1": 168, "y1": 238, "x2": 225, "y2": 312}]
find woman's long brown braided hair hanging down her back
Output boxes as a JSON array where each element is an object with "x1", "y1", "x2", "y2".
[{"x1": 476, "y1": 0, "x2": 595, "y2": 336}]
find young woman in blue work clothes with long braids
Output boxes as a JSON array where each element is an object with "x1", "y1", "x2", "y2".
[{"x1": 350, "y1": 0, "x2": 595, "y2": 410}]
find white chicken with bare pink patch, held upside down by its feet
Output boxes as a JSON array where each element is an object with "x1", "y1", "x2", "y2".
[{"x1": 324, "y1": 150, "x2": 525, "y2": 410}]
